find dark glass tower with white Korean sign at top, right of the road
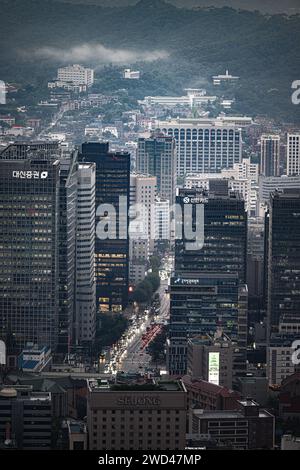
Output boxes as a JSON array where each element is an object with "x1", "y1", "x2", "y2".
[{"x1": 175, "y1": 188, "x2": 247, "y2": 283}]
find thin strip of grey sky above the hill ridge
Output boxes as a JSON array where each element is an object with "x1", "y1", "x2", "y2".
[{"x1": 59, "y1": 0, "x2": 300, "y2": 13}]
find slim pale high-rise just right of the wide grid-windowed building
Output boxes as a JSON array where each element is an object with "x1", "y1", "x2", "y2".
[{"x1": 260, "y1": 134, "x2": 280, "y2": 176}]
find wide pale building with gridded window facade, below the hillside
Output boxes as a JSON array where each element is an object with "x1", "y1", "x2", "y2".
[{"x1": 156, "y1": 118, "x2": 243, "y2": 176}]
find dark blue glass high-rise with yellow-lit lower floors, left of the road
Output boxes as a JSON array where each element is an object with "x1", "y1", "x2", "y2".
[{"x1": 80, "y1": 142, "x2": 130, "y2": 312}]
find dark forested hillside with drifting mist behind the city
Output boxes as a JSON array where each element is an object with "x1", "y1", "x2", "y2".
[{"x1": 0, "y1": 0, "x2": 300, "y2": 119}]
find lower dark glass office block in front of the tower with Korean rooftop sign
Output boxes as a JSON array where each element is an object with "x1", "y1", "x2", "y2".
[{"x1": 167, "y1": 271, "x2": 247, "y2": 375}]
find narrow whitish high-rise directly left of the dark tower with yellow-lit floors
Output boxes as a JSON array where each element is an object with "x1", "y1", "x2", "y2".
[{"x1": 75, "y1": 163, "x2": 96, "y2": 344}]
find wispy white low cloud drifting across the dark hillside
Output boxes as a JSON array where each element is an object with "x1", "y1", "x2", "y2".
[{"x1": 30, "y1": 44, "x2": 168, "y2": 64}]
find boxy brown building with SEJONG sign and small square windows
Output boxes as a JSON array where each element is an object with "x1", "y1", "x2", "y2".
[{"x1": 87, "y1": 379, "x2": 187, "y2": 450}]
